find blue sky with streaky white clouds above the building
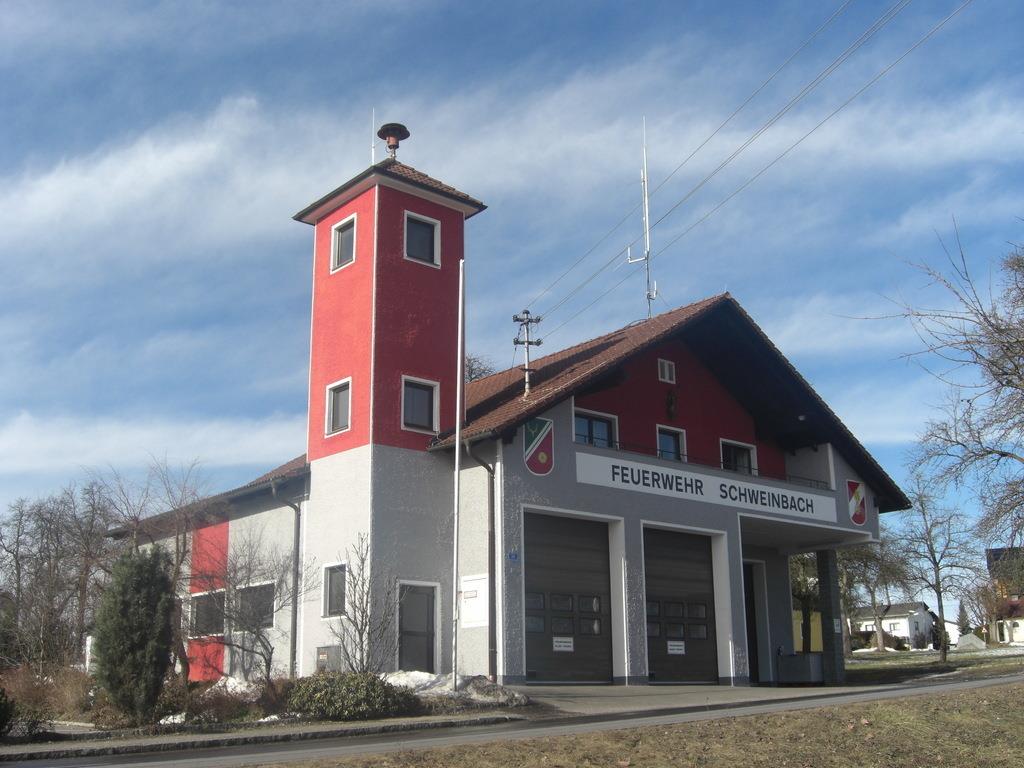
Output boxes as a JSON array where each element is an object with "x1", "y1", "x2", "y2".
[{"x1": 0, "y1": 0, "x2": 1024, "y2": 528}]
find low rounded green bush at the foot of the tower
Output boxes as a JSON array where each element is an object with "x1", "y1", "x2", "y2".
[{"x1": 289, "y1": 672, "x2": 418, "y2": 720}]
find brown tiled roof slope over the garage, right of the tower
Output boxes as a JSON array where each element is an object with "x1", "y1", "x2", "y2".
[{"x1": 435, "y1": 294, "x2": 732, "y2": 447}]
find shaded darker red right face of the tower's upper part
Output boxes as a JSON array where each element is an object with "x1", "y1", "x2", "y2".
[{"x1": 373, "y1": 186, "x2": 464, "y2": 449}]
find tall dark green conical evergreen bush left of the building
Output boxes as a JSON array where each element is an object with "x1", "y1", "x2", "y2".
[{"x1": 95, "y1": 547, "x2": 174, "y2": 723}]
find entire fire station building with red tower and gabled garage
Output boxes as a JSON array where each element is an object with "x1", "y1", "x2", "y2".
[{"x1": 132, "y1": 129, "x2": 908, "y2": 685}]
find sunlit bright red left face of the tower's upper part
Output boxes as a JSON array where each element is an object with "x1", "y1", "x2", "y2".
[{"x1": 306, "y1": 188, "x2": 375, "y2": 461}]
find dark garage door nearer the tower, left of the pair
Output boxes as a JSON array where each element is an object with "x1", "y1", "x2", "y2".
[{"x1": 523, "y1": 514, "x2": 611, "y2": 683}]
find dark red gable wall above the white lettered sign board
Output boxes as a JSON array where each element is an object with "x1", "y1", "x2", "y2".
[{"x1": 575, "y1": 341, "x2": 785, "y2": 477}]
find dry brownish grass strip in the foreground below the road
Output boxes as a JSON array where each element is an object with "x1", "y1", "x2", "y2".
[{"x1": 268, "y1": 684, "x2": 1024, "y2": 768}]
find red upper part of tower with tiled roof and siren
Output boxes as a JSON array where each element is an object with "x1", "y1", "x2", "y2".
[{"x1": 295, "y1": 124, "x2": 485, "y2": 462}]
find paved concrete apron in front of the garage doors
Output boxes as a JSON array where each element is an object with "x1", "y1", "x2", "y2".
[{"x1": 509, "y1": 685, "x2": 900, "y2": 715}]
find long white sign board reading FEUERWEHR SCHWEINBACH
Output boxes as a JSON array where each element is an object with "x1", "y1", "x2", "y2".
[{"x1": 577, "y1": 452, "x2": 836, "y2": 522}]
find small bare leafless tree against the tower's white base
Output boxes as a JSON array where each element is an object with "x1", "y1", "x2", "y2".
[{"x1": 331, "y1": 534, "x2": 398, "y2": 673}]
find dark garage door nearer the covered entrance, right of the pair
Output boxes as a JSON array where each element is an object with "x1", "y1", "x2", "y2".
[{"x1": 643, "y1": 528, "x2": 718, "y2": 683}]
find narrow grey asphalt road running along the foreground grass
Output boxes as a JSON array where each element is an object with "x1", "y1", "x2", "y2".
[{"x1": 16, "y1": 675, "x2": 1024, "y2": 768}]
